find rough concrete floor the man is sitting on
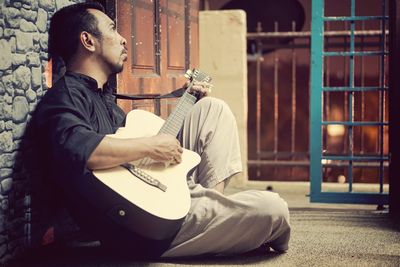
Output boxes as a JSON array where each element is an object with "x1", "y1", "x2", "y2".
[{"x1": 9, "y1": 182, "x2": 400, "y2": 267}]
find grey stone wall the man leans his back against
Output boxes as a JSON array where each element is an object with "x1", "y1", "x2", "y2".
[{"x1": 0, "y1": 0, "x2": 81, "y2": 264}]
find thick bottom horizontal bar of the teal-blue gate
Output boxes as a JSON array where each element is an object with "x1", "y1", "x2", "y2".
[{"x1": 310, "y1": 192, "x2": 389, "y2": 205}]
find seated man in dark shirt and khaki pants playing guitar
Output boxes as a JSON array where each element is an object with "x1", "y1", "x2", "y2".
[{"x1": 32, "y1": 3, "x2": 290, "y2": 257}]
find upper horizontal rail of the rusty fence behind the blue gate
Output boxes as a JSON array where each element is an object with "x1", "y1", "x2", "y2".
[{"x1": 247, "y1": 30, "x2": 389, "y2": 40}]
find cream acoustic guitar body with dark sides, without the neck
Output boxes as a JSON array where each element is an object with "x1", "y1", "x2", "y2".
[{"x1": 93, "y1": 110, "x2": 200, "y2": 240}]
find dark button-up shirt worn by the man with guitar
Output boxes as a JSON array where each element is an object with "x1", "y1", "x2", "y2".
[{"x1": 29, "y1": 72, "x2": 171, "y2": 256}]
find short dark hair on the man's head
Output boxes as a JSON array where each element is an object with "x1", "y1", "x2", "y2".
[{"x1": 49, "y1": 2, "x2": 104, "y2": 63}]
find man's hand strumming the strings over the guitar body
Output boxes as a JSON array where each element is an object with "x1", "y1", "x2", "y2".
[{"x1": 149, "y1": 133, "x2": 183, "y2": 164}]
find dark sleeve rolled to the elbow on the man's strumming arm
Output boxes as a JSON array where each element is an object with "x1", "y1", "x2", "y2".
[{"x1": 38, "y1": 88, "x2": 105, "y2": 176}]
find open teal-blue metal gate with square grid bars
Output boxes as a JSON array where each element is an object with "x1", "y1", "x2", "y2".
[{"x1": 310, "y1": 0, "x2": 389, "y2": 205}]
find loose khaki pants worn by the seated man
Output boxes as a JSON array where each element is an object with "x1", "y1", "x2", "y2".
[{"x1": 162, "y1": 97, "x2": 290, "y2": 257}]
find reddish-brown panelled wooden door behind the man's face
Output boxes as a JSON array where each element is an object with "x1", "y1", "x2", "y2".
[{"x1": 116, "y1": 0, "x2": 199, "y2": 118}]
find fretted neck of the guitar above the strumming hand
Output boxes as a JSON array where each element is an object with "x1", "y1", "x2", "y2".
[{"x1": 159, "y1": 90, "x2": 197, "y2": 136}]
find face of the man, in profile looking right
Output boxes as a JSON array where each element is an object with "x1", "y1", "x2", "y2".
[{"x1": 88, "y1": 9, "x2": 128, "y2": 74}]
